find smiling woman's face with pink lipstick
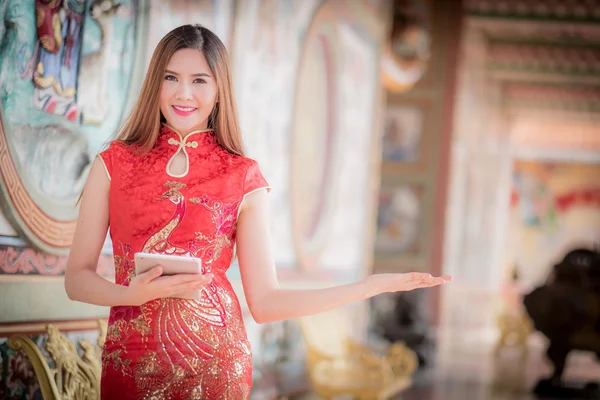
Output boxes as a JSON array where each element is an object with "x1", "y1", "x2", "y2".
[{"x1": 160, "y1": 49, "x2": 217, "y2": 135}]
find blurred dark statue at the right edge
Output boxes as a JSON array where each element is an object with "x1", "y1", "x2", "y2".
[{"x1": 523, "y1": 248, "x2": 600, "y2": 399}]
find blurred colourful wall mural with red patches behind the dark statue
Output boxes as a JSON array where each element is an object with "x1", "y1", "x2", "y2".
[{"x1": 506, "y1": 161, "x2": 600, "y2": 285}]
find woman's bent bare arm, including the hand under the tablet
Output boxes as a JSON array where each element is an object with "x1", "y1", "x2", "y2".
[{"x1": 65, "y1": 158, "x2": 211, "y2": 306}]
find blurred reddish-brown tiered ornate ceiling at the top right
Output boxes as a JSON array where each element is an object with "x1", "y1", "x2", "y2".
[{"x1": 465, "y1": 0, "x2": 600, "y2": 151}]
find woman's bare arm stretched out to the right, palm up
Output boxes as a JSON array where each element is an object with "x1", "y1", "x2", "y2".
[{"x1": 237, "y1": 190, "x2": 450, "y2": 323}]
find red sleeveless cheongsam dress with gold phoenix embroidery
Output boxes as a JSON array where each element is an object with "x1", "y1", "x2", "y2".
[{"x1": 100, "y1": 126, "x2": 268, "y2": 400}]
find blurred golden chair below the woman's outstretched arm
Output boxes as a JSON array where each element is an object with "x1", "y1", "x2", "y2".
[{"x1": 299, "y1": 310, "x2": 418, "y2": 400}]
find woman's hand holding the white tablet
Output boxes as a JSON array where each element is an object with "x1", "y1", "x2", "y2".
[{"x1": 127, "y1": 265, "x2": 213, "y2": 306}]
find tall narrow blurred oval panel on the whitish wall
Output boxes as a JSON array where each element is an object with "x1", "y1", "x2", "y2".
[{"x1": 289, "y1": 2, "x2": 342, "y2": 269}]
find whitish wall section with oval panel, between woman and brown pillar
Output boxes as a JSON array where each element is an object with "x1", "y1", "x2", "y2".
[{"x1": 233, "y1": 0, "x2": 378, "y2": 279}]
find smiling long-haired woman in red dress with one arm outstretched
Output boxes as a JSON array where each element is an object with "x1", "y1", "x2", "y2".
[{"x1": 65, "y1": 25, "x2": 448, "y2": 400}]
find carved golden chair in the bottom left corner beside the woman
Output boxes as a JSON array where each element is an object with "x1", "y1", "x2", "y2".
[{"x1": 8, "y1": 320, "x2": 106, "y2": 400}]
